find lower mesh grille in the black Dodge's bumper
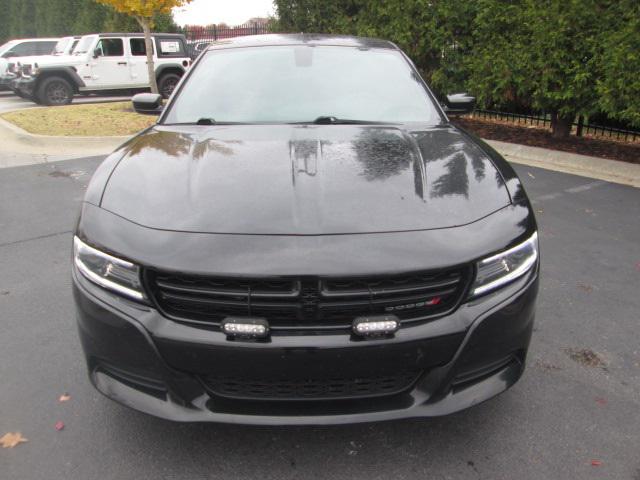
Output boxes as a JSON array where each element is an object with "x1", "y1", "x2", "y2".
[{"x1": 201, "y1": 370, "x2": 420, "y2": 400}]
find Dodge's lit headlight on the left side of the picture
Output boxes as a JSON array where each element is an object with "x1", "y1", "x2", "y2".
[{"x1": 73, "y1": 237, "x2": 145, "y2": 300}]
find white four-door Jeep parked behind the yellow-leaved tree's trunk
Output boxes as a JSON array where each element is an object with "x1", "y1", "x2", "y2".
[{"x1": 15, "y1": 33, "x2": 191, "y2": 105}]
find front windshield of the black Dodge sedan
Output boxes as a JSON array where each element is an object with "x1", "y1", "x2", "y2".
[{"x1": 164, "y1": 46, "x2": 440, "y2": 124}]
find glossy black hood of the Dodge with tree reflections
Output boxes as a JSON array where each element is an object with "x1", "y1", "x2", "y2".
[{"x1": 100, "y1": 125, "x2": 511, "y2": 235}]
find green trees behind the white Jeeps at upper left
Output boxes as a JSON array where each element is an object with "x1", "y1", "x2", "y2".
[{"x1": 0, "y1": 0, "x2": 178, "y2": 44}]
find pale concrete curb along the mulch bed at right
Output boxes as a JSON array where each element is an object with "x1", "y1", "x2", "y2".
[{"x1": 486, "y1": 140, "x2": 640, "y2": 188}]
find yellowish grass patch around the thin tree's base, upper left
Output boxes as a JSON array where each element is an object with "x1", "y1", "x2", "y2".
[{"x1": 1, "y1": 102, "x2": 157, "y2": 137}]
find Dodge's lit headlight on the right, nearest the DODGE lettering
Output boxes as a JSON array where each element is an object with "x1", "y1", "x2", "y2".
[{"x1": 471, "y1": 232, "x2": 538, "y2": 296}]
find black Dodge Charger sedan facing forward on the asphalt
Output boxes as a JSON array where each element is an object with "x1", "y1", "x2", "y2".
[{"x1": 73, "y1": 34, "x2": 539, "y2": 424}]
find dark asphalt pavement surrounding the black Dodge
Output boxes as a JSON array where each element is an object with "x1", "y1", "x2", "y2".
[{"x1": 0, "y1": 158, "x2": 640, "y2": 480}]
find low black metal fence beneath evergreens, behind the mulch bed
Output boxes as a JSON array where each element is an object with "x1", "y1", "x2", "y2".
[{"x1": 472, "y1": 110, "x2": 640, "y2": 142}]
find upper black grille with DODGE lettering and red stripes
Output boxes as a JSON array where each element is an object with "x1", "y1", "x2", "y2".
[{"x1": 145, "y1": 267, "x2": 470, "y2": 334}]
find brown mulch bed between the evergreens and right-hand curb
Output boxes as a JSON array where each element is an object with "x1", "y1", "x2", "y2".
[{"x1": 452, "y1": 117, "x2": 640, "y2": 164}]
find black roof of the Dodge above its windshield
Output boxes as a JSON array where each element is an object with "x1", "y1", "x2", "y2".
[{"x1": 209, "y1": 33, "x2": 398, "y2": 50}]
